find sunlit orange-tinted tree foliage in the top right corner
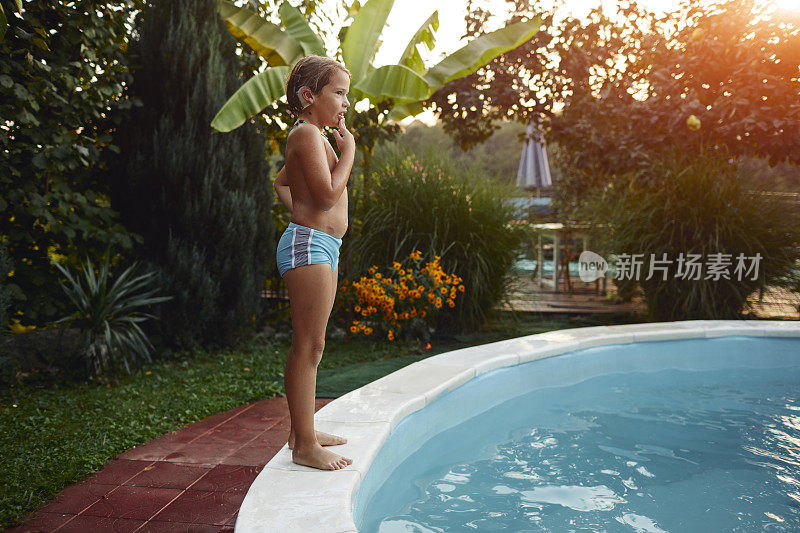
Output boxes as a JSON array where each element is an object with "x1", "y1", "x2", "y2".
[{"x1": 430, "y1": 0, "x2": 800, "y2": 172}]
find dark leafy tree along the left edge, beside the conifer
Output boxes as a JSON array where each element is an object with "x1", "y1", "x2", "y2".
[{"x1": 0, "y1": 0, "x2": 139, "y2": 324}]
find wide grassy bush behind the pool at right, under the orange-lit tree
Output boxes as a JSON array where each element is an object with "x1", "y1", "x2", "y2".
[{"x1": 579, "y1": 144, "x2": 800, "y2": 320}]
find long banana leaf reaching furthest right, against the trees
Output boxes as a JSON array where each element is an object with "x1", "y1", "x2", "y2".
[{"x1": 424, "y1": 19, "x2": 541, "y2": 88}]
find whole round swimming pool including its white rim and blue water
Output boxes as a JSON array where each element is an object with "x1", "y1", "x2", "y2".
[{"x1": 236, "y1": 321, "x2": 800, "y2": 532}]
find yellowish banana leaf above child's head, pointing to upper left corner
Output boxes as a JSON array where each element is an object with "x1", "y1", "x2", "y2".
[{"x1": 217, "y1": 0, "x2": 303, "y2": 66}]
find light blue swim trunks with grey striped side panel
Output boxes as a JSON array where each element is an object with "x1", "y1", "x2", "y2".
[{"x1": 275, "y1": 222, "x2": 342, "y2": 277}]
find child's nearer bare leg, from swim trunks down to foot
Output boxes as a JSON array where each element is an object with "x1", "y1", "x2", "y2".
[{"x1": 283, "y1": 263, "x2": 352, "y2": 469}]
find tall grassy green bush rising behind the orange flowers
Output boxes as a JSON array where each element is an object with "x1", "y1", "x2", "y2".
[{"x1": 352, "y1": 145, "x2": 522, "y2": 332}]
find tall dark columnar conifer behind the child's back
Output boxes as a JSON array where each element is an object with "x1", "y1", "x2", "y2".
[{"x1": 109, "y1": 0, "x2": 274, "y2": 346}]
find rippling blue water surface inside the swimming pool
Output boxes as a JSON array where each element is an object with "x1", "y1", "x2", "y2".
[{"x1": 378, "y1": 367, "x2": 800, "y2": 533}]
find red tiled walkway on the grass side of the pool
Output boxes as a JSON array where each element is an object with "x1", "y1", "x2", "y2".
[{"x1": 7, "y1": 397, "x2": 331, "y2": 533}]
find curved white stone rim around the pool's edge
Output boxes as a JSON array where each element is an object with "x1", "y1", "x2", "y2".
[{"x1": 234, "y1": 320, "x2": 800, "y2": 533}]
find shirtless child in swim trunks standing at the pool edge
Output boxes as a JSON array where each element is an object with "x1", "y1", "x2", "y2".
[{"x1": 275, "y1": 55, "x2": 355, "y2": 470}]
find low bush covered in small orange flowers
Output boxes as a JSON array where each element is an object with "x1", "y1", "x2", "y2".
[{"x1": 339, "y1": 250, "x2": 465, "y2": 341}]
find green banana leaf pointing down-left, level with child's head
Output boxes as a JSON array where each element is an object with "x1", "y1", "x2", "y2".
[{"x1": 211, "y1": 66, "x2": 289, "y2": 131}]
